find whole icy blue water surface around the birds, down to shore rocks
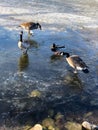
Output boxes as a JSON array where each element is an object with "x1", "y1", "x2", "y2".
[{"x1": 0, "y1": 0, "x2": 98, "y2": 129}]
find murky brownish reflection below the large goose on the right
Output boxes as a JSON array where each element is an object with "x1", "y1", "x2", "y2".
[{"x1": 64, "y1": 72, "x2": 82, "y2": 88}]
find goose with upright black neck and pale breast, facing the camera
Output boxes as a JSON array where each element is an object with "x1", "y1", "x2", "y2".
[{"x1": 18, "y1": 31, "x2": 30, "y2": 54}]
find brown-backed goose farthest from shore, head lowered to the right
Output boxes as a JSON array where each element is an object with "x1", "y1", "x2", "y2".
[{"x1": 19, "y1": 22, "x2": 42, "y2": 35}]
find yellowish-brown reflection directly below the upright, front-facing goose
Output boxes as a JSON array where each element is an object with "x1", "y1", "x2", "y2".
[{"x1": 18, "y1": 54, "x2": 29, "y2": 72}]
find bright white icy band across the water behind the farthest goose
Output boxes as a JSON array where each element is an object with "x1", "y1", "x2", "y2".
[{"x1": 0, "y1": 5, "x2": 98, "y2": 31}]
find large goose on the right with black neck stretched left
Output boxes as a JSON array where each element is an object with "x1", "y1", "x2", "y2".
[{"x1": 63, "y1": 52, "x2": 89, "y2": 73}]
